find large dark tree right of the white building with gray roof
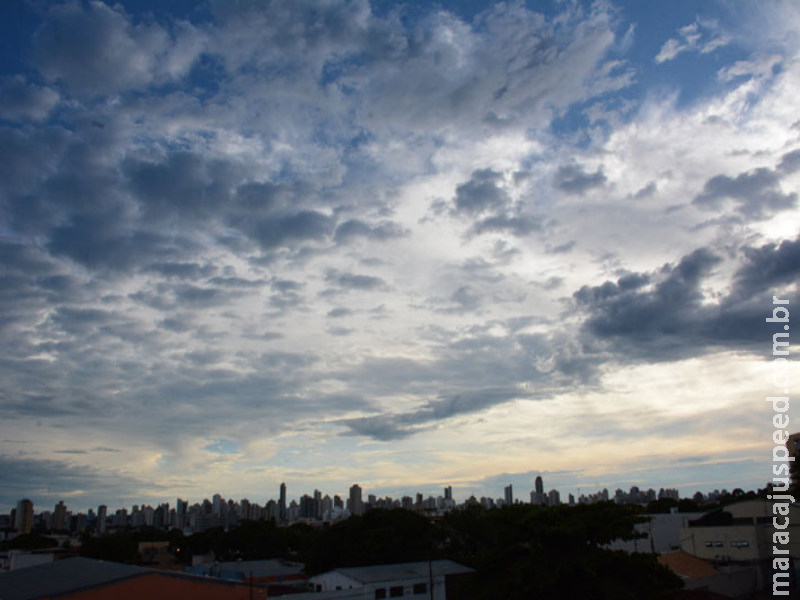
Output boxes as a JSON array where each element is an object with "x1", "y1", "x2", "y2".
[{"x1": 443, "y1": 503, "x2": 682, "y2": 600}]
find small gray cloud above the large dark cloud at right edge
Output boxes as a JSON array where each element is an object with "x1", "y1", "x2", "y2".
[{"x1": 692, "y1": 165, "x2": 797, "y2": 219}]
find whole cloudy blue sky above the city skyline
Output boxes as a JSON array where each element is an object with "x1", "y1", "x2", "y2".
[{"x1": 0, "y1": 0, "x2": 800, "y2": 511}]
